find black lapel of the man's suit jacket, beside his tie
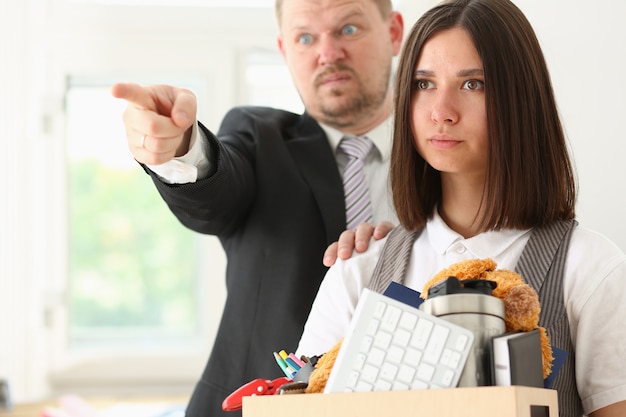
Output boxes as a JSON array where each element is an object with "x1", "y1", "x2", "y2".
[{"x1": 287, "y1": 114, "x2": 346, "y2": 244}]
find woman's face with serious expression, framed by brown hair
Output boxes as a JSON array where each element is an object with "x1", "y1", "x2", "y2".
[{"x1": 411, "y1": 28, "x2": 488, "y2": 180}]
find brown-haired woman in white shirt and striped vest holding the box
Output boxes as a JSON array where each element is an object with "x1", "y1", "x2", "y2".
[{"x1": 298, "y1": 0, "x2": 626, "y2": 417}]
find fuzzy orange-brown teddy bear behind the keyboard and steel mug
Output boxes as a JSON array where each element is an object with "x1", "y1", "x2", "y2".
[{"x1": 306, "y1": 259, "x2": 554, "y2": 393}]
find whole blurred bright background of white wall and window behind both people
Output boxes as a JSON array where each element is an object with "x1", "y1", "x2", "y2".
[{"x1": 0, "y1": 0, "x2": 626, "y2": 402}]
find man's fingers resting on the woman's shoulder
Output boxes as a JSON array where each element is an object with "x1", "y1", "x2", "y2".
[{"x1": 324, "y1": 221, "x2": 394, "y2": 266}]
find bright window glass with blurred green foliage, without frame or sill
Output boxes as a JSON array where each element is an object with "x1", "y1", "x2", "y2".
[{"x1": 66, "y1": 78, "x2": 210, "y2": 350}]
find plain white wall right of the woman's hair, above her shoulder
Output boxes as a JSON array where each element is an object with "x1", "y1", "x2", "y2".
[{"x1": 520, "y1": 0, "x2": 626, "y2": 250}]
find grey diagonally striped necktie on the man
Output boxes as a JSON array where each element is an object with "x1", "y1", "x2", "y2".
[{"x1": 339, "y1": 136, "x2": 373, "y2": 230}]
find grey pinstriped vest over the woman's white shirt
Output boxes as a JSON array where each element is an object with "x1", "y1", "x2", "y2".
[{"x1": 368, "y1": 220, "x2": 583, "y2": 417}]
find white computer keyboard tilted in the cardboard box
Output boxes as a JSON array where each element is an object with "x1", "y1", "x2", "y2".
[{"x1": 324, "y1": 289, "x2": 474, "y2": 393}]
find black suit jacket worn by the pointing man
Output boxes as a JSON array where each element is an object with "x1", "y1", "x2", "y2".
[{"x1": 148, "y1": 107, "x2": 346, "y2": 417}]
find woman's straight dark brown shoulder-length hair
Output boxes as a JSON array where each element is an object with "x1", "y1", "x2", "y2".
[{"x1": 390, "y1": 0, "x2": 577, "y2": 230}]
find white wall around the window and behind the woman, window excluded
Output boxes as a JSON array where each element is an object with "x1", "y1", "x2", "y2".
[{"x1": 0, "y1": 0, "x2": 626, "y2": 401}]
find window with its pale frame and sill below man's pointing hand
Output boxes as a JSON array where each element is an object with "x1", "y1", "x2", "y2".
[{"x1": 49, "y1": 75, "x2": 225, "y2": 395}]
